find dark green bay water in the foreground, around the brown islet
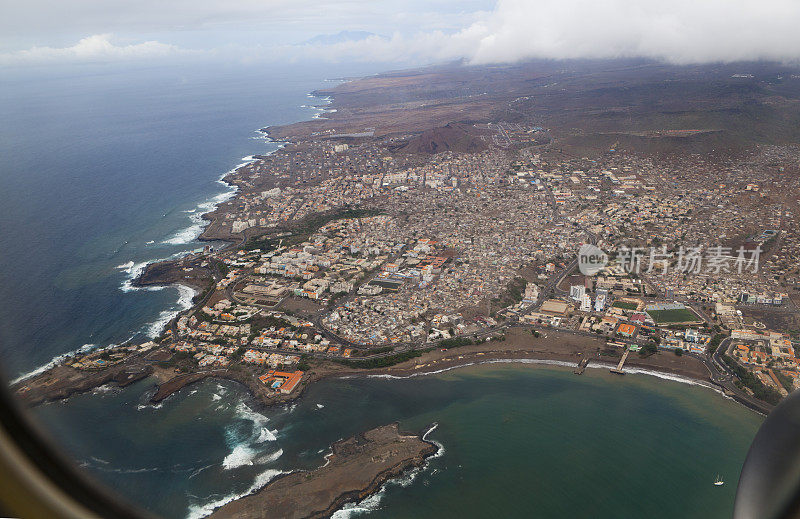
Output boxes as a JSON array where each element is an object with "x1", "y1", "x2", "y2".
[{"x1": 32, "y1": 364, "x2": 761, "y2": 518}]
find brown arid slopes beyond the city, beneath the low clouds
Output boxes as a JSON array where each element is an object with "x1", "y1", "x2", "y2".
[{"x1": 266, "y1": 60, "x2": 800, "y2": 155}]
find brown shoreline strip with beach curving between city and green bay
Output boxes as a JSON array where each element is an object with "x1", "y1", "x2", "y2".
[{"x1": 13, "y1": 324, "x2": 764, "y2": 415}]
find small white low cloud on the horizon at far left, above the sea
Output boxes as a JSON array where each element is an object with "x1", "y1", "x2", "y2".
[{"x1": 0, "y1": 34, "x2": 194, "y2": 65}]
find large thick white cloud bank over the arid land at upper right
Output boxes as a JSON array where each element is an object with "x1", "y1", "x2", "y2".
[{"x1": 288, "y1": 0, "x2": 800, "y2": 64}]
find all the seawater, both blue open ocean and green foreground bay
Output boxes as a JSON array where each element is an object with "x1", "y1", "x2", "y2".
[{"x1": 0, "y1": 64, "x2": 760, "y2": 518}]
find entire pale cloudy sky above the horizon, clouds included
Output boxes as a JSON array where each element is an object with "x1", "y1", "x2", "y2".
[{"x1": 0, "y1": 0, "x2": 800, "y2": 67}]
